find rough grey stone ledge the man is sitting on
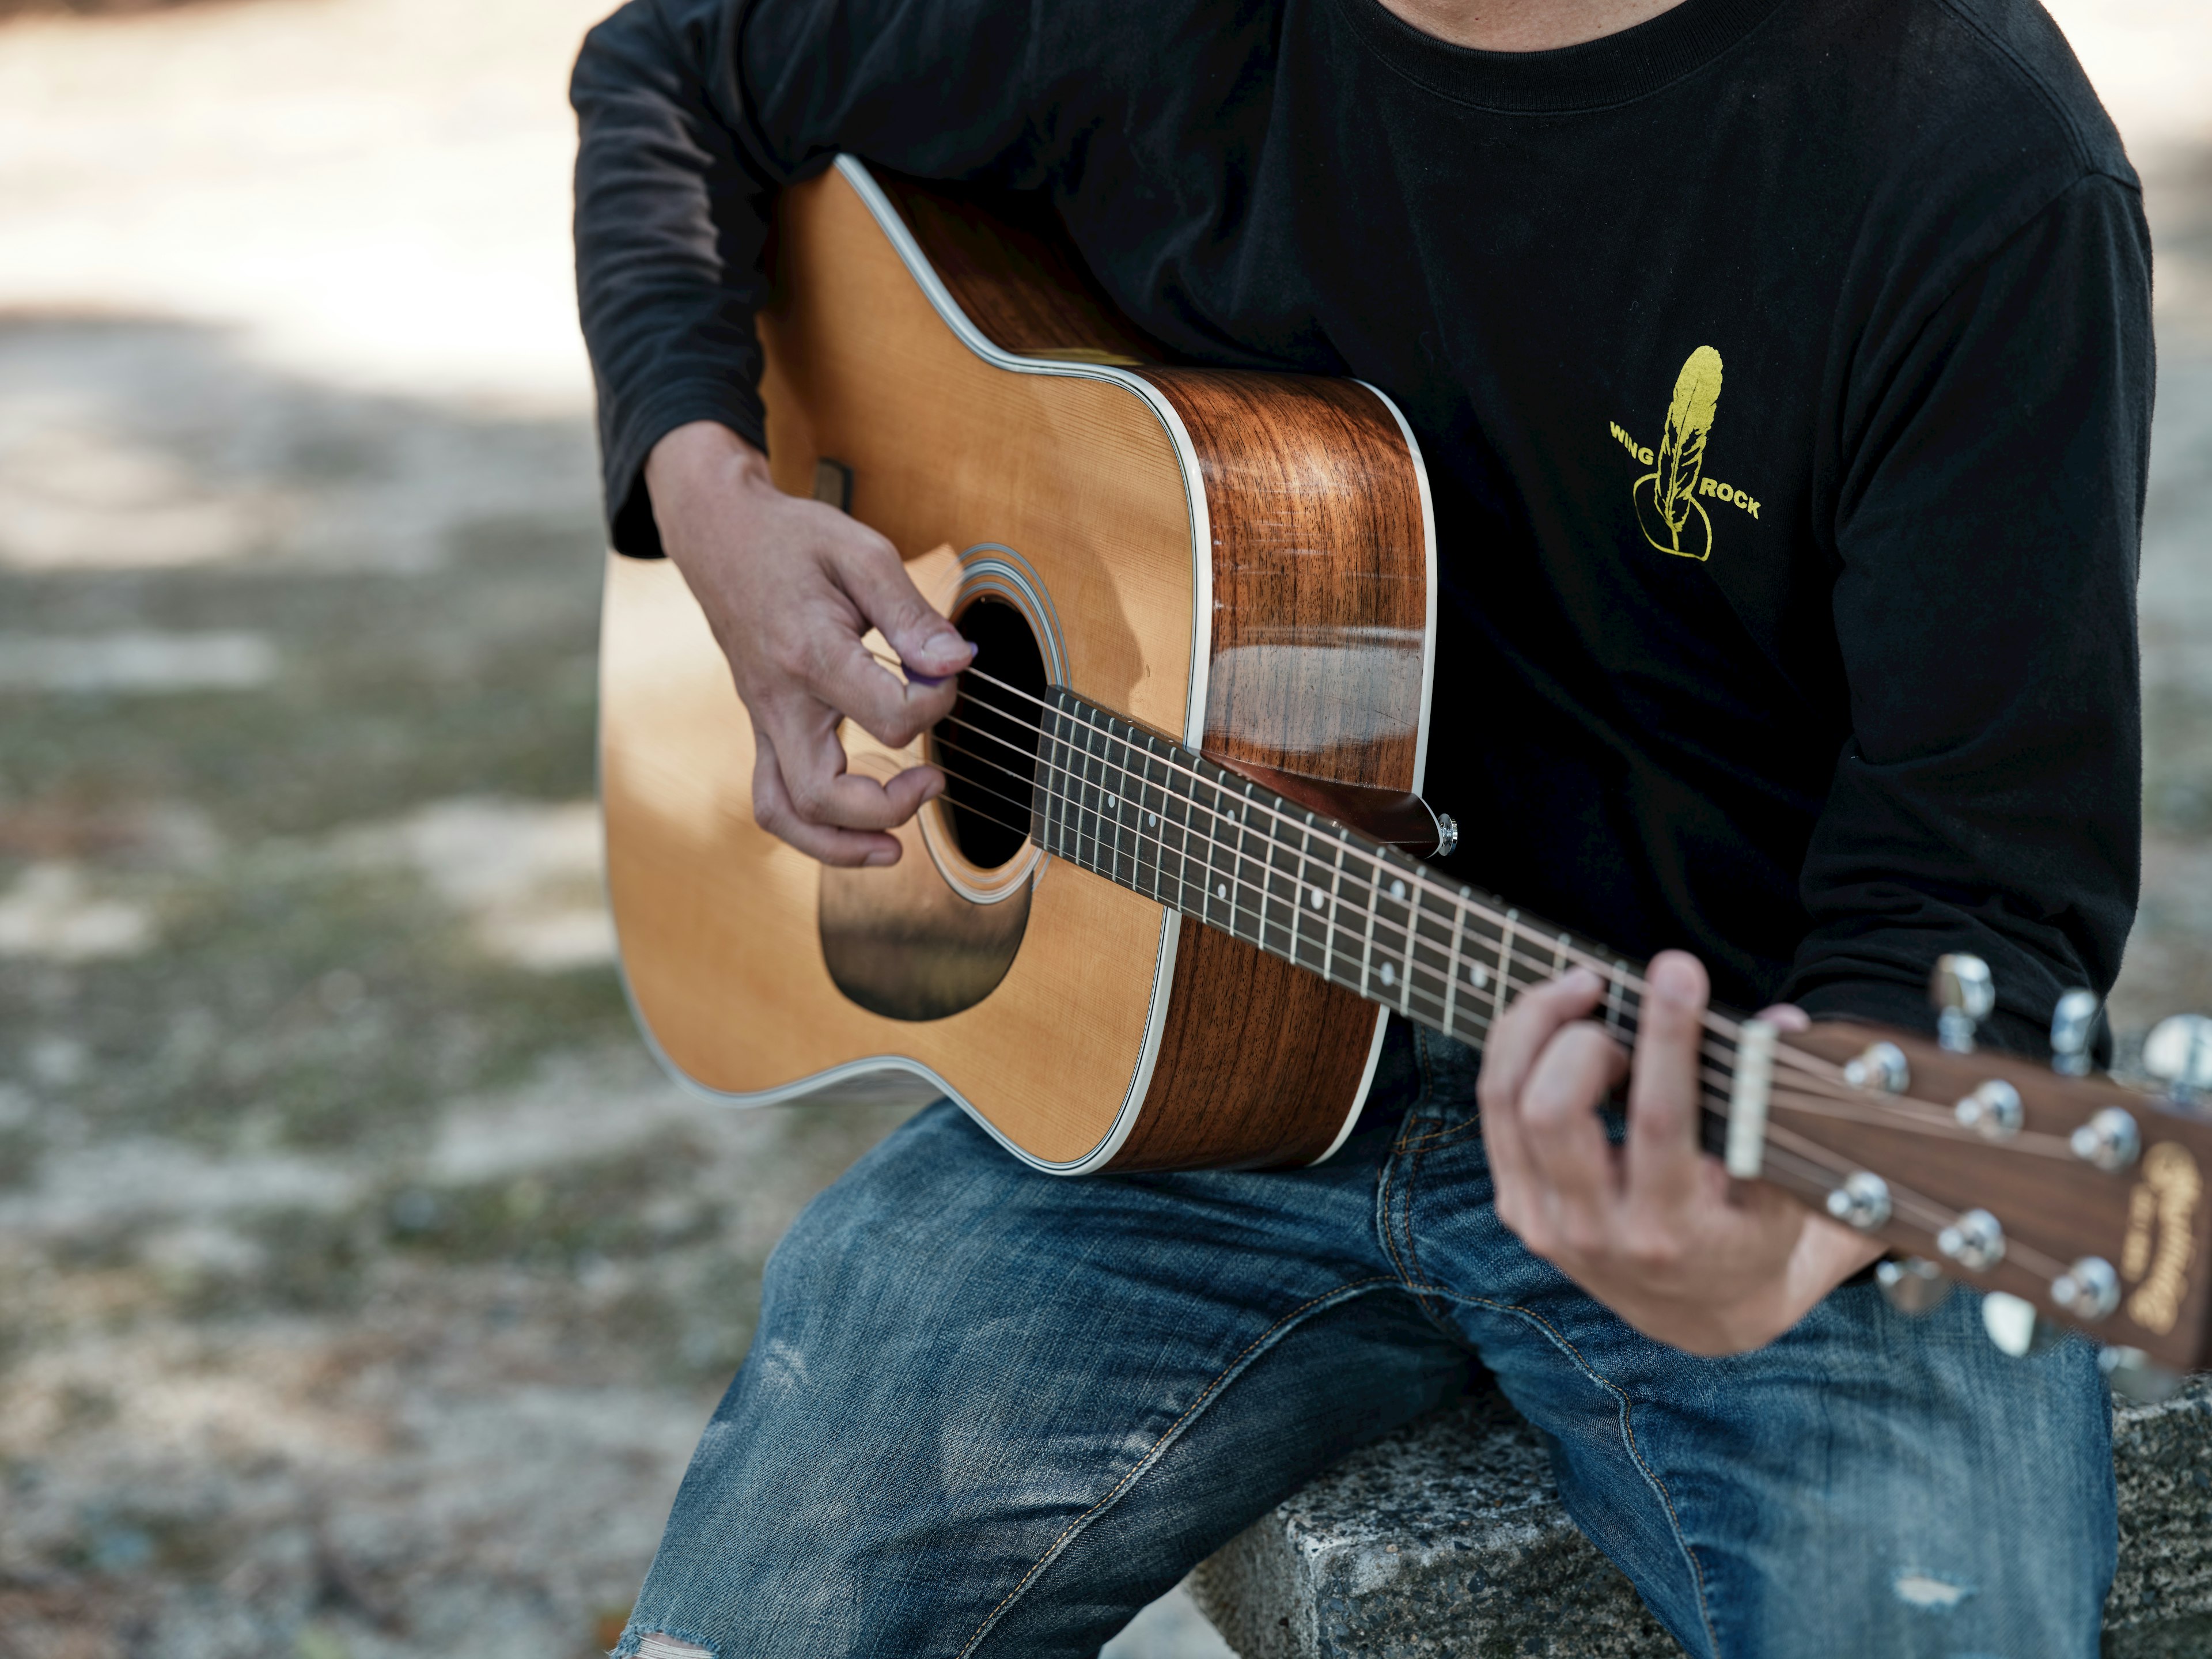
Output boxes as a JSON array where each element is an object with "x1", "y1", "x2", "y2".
[{"x1": 1190, "y1": 1378, "x2": 2212, "y2": 1659}]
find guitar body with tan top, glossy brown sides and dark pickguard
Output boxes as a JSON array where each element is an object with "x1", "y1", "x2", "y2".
[{"x1": 601, "y1": 159, "x2": 1435, "y2": 1175}]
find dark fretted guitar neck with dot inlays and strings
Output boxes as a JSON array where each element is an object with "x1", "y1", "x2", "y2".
[{"x1": 1031, "y1": 688, "x2": 1738, "y2": 1111}]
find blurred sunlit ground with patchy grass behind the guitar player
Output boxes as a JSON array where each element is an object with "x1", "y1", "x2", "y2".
[{"x1": 0, "y1": 0, "x2": 2212, "y2": 1659}]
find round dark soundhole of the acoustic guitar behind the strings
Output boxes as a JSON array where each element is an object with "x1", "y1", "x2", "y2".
[{"x1": 929, "y1": 595, "x2": 1046, "y2": 869}]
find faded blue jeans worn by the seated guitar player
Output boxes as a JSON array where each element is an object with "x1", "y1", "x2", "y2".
[{"x1": 617, "y1": 1027, "x2": 2115, "y2": 1659}]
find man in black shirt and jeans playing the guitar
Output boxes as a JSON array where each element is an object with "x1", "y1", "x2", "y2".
[{"x1": 575, "y1": 0, "x2": 2150, "y2": 1659}]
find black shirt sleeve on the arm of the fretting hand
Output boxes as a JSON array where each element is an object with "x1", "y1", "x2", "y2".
[{"x1": 1783, "y1": 175, "x2": 2152, "y2": 1053}]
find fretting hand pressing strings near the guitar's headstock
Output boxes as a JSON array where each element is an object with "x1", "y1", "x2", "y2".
[{"x1": 1480, "y1": 951, "x2": 1883, "y2": 1354}]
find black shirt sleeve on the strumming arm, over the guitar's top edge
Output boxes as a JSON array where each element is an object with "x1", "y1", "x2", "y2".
[{"x1": 571, "y1": 0, "x2": 1088, "y2": 558}]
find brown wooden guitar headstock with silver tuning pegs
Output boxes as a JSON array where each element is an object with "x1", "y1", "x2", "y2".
[{"x1": 1761, "y1": 958, "x2": 2212, "y2": 1372}]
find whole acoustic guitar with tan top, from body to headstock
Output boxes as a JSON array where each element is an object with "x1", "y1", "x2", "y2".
[{"x1": 601, "y1": 157, "x2": 2212, "y2": 1369}]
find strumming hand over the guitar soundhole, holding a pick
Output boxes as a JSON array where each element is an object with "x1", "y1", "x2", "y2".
[{"x1": 646, "y1": 421, "x2": 975, "y2": 865}]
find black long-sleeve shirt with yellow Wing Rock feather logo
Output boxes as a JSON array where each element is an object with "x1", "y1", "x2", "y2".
[{"x1": 573, "y1": 0, "x2": 2152, "y2": 1046}]
